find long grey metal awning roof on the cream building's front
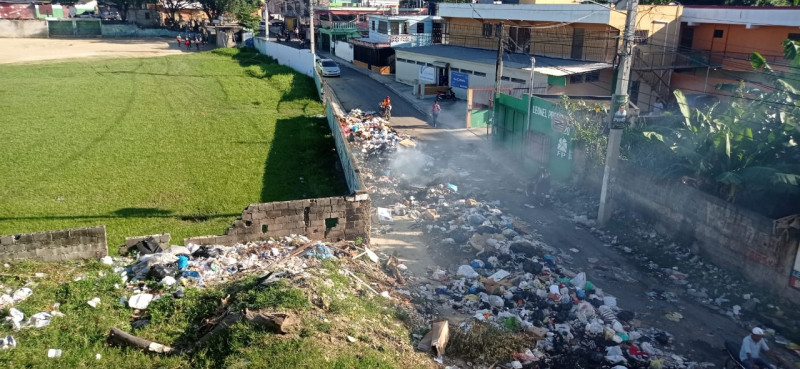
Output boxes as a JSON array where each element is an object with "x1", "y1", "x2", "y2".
[{"x1": 395, "y1": 45, "x2": 612, "y2": 76}]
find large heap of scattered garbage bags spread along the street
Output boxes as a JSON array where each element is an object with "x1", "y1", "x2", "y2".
[{"x1": 344, "y1": 113, "x2": 710, "y2": 369}]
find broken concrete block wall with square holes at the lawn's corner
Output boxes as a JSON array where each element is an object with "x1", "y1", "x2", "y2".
[{"x1": 184, "y1": 194, "x2": 371, "y2": 245}]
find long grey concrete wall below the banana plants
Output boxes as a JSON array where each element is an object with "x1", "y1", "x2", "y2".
[{"x1": 575, "y1": 151, "x2": 800, "y2": 303}]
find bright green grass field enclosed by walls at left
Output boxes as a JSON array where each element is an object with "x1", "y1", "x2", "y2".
[{"x1": 0, "y1": 49, "x2": 347, "y2": 249}]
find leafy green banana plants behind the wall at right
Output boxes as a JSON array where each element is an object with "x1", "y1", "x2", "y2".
[{"x1": 643, "y1": 40, "x2": 800, "y2": 216}]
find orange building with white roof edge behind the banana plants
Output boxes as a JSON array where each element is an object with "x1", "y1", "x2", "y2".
[{"x1": 671, "y1": 6, "x2": 800, "y2": 100}]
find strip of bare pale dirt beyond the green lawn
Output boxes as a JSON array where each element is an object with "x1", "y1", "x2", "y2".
[{"x1": 0, "y1": 38, "x2": 197, "y2": 64}]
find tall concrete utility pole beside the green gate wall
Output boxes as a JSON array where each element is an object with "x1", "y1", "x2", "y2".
[{"x1": 597, "y1": 0, "x2": 639, "y2": 226}]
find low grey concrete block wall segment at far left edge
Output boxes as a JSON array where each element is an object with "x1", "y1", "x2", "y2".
[{"x1": 0, "y1": 226, "x2": 108, "y2": 262}]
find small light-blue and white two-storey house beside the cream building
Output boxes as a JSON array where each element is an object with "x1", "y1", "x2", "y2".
[{"x1": 350, "y1": 15, "x2": 442, "y2": 74}]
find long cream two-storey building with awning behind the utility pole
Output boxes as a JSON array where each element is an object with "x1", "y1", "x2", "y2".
[{"x1": 396, "y1": 0, "x2": 682, "y2": 110}]
